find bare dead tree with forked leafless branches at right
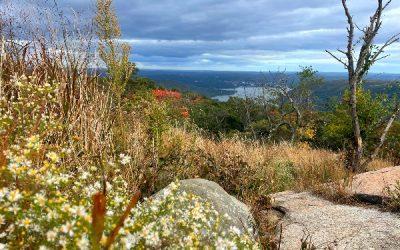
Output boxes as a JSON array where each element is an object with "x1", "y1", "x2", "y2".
[{"x1": 327, "y1": 0, "x2": 400, "y2": 171}]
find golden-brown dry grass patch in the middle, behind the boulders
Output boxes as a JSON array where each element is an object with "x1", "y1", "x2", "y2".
[{"x1": 157, "y1": 128, "x2": 346, "y2": 201}]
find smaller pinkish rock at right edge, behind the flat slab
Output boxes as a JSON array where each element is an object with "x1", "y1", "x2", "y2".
[{"x1": 348, "y1": 166, "x2": 400, "y2": 203}]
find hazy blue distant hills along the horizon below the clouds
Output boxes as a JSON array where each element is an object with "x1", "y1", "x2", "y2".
[{"x1": 139, "y1": 70, "x2": 400, "y2": 105}]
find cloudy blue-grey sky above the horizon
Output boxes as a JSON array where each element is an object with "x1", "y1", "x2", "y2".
[{"x1": 7, "y1": 0, "x2": 400, "y2": 73}]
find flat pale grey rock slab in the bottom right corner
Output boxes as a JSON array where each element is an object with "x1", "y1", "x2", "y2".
[{"x1": 273, "y1": 192, "x2": 400, "y2": 249}]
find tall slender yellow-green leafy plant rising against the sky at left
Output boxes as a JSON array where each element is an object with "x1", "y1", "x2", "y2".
[{"x1": 95, "y1": 0, "x2": 135, "y2": 102}]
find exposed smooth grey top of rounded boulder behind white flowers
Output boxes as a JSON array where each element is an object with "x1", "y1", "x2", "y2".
[{"x1": 156, "y1": 179, "x2": 256, "y2": 236}]
